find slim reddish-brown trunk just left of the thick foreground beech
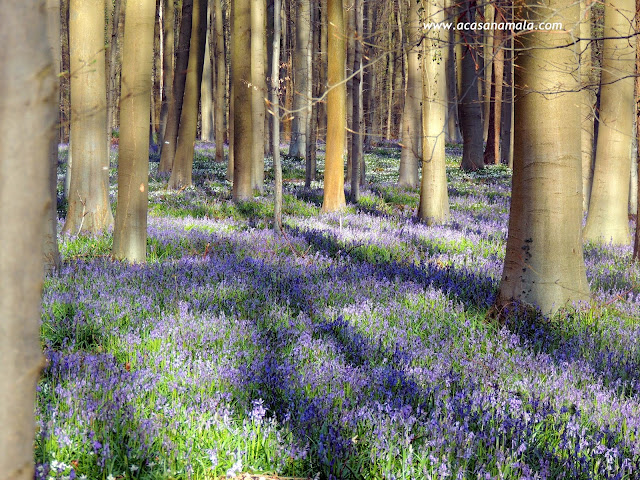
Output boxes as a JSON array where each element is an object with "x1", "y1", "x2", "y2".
[{"x1": 484, "y1": 2, "x2": 505, "y2": 165}]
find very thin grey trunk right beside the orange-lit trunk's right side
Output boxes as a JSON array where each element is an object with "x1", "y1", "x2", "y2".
[{"x1": 351, "y1": 0, "x2": 364, "y2": 203}]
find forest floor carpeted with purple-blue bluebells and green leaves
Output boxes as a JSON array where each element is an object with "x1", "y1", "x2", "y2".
[{"x1": 35, "y1": 145, "x2": 640, "y2": 480}]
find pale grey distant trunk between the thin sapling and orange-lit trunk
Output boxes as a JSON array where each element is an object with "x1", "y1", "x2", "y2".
[{"x1": 289, "y1": 0, "x2": 311, "y2": 157}]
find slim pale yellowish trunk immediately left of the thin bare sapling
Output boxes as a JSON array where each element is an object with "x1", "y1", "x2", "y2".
[{"x1": 251, "y1": 0, "x2": 267, "y2": 194}]
